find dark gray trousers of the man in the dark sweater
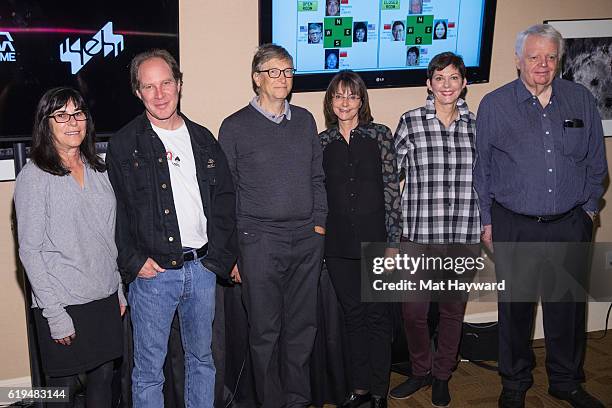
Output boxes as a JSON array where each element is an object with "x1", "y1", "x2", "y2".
[{"x1": 238, "y1": 225, "x2": 323, "y2": 407}]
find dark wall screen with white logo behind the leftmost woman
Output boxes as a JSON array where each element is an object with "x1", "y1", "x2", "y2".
[{"x1": 0, "y1": 0, "x2": 179, "y2": 143}]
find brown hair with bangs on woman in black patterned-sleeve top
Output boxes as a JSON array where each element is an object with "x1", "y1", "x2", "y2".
[{"x1": 323, "y1": 70, "x2": 374, "y2": 129}]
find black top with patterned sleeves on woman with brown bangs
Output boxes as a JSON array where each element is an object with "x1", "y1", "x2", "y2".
[{"x1": 319, "y1": 123, "x2": 401, "y2": 258}]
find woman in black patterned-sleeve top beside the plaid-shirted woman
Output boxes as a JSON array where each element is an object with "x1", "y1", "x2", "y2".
[{"x1": 319, "y1": 71, "x2": 401, "y2": 408}]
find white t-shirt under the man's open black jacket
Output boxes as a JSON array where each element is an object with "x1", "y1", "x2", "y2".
[{"x1": 151, "y1": 123, "x2": 208, "y2": 248}]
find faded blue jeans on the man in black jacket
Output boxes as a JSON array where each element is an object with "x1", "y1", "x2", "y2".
[{"x1": 129, "y1": 260, "x2": 216, "y2": 408}]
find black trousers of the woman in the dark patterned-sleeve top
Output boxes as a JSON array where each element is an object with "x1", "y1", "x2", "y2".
[{"x1": 325, "y1": 257, "x2": 392, "y2": 396}]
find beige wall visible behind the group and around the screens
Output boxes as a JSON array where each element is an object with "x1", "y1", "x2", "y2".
[{"x1": 0, "y1": 0, "x2": 612, "y2": 381}]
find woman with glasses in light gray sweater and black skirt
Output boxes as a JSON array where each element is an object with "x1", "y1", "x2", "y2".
[{"x1": 15, "y1": 88, "x2": 126, "y2": 408}]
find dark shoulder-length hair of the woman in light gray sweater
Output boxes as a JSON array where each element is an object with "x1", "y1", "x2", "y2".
[{"x1": 30, "y1": 87, "x2": 106, "y2": 176}]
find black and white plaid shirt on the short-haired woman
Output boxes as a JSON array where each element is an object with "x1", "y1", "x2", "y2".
[{"x1": 395, "y1": 96, "x2": 480, "y2": 244}]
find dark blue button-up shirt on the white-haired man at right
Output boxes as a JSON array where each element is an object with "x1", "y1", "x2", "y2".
[{"x1": 474, "y1": 78, "x2": 608, "y2": 225}]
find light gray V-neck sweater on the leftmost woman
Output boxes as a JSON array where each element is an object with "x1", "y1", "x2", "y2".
[{"x1": 15, "y1": 162, "x2": 126, "y2": 339}]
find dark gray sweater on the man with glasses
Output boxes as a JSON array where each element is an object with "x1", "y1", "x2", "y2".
[{"x1": 219, "y1": 104, "x2": 327, "y2": 228}]
